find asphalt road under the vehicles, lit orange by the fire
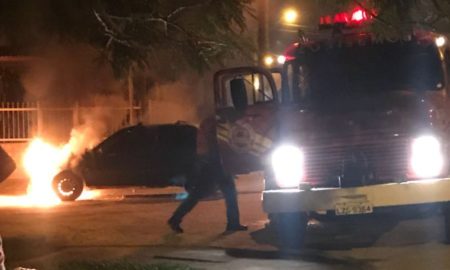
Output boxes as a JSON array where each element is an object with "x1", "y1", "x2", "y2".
[{"x1": 0, "y1": 175, "x2": 450, "y2": 269}]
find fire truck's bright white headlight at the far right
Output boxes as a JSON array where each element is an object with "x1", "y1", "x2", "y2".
[{"x1": 411, "y1": 135, "x2": 444, "y2": 178}]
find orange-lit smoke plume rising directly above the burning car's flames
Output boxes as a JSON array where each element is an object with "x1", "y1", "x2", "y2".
[{"x1": 22, "y1": 43, "x2": 128, "y2": 155}]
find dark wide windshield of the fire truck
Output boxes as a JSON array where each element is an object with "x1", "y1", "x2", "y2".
[{"x1": 288, "y1": 42, "x2": 444, "y2": 106}]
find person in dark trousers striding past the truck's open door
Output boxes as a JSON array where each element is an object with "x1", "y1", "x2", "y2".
[{"x1": 167, "y1": 119, "x2": 247, "y2": 233}]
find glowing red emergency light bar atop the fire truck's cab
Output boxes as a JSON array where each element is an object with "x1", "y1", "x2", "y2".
[{"x1": 320, "y1": 7, "x2": 372, "y2": 26}]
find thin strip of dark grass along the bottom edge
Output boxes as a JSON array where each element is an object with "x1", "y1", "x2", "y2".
[{"x1": 58, "y1": 262, "x2": 196, "y2": 270}]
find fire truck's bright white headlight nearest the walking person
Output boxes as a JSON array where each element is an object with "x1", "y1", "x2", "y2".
[{"x1": 272, "y1": 145, "x2": 304, "y2": 188}]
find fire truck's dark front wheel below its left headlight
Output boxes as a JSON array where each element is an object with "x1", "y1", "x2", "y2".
[{"x1": 269, "y1": 212, "x2": 308, "y2": 249}]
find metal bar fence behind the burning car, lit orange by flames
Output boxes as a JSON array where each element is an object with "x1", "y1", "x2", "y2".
[{"x1": 0, "y1": 102, "x2": 141, "y2": 143}]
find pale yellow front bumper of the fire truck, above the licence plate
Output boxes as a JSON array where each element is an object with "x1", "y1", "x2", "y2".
[{"x1": 263, "y1": 178, "x2": 450, "y2": 213}]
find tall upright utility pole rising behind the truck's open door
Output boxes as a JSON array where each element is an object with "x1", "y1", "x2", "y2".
[{"x1": 258, "y1": 0, "x2": 269, "y2": 66}]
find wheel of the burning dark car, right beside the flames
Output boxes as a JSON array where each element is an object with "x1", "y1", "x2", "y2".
[{"x1": 52, "y1": 170, "x2": 84, "y2": 201}]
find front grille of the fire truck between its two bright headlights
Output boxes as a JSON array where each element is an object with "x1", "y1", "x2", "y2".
[{"x1": 304, "y1": 133, "x2": 410, "y2": 186}]
